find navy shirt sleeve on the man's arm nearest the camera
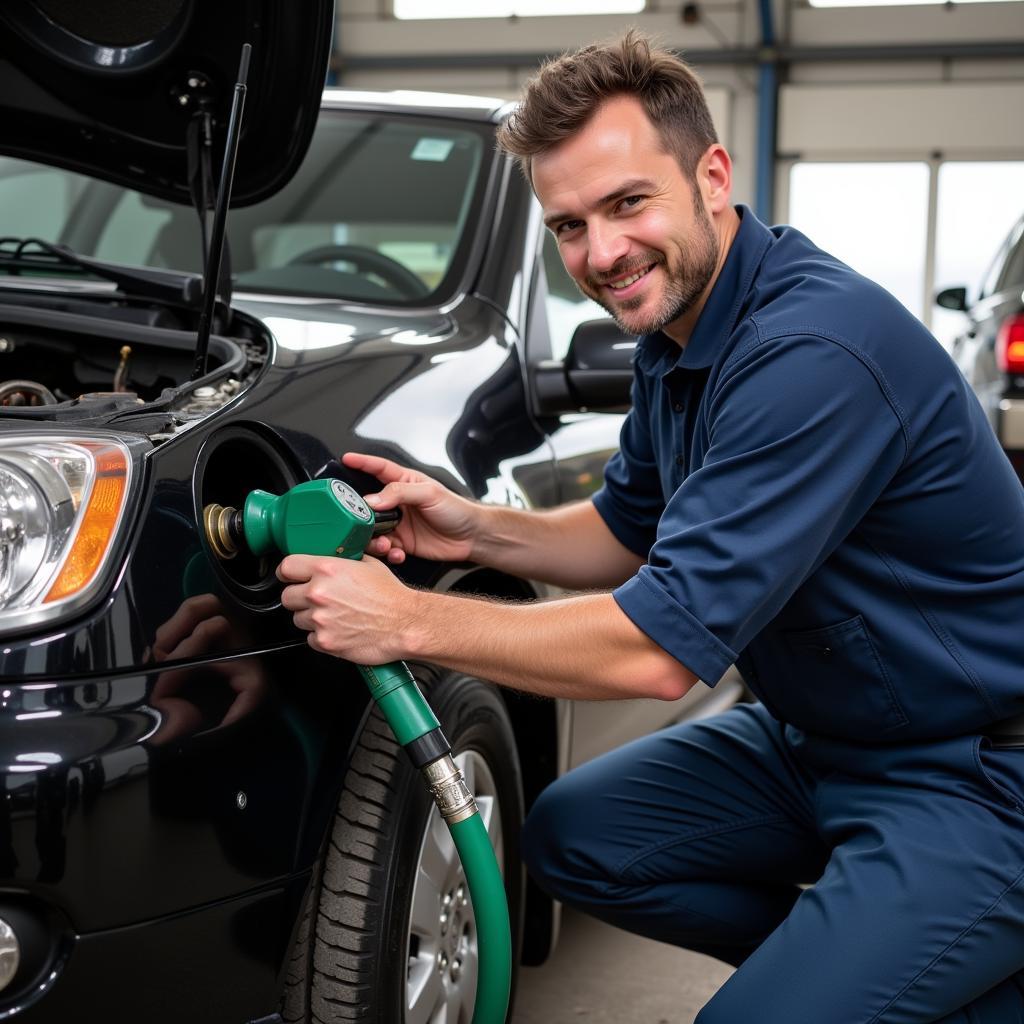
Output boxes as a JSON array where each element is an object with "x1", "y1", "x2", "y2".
[{"x1": 614, "y1": 334, "x2": 909, "y2": 684}]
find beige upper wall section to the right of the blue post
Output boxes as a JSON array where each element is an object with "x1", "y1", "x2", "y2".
[{"x1": 778, "y1": 3, "x2": 1024, "y2": 178}]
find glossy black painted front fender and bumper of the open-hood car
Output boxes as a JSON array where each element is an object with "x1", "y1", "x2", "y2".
[{"x1": 0, "y1": 94, "x2": 618, "y2": 1024}]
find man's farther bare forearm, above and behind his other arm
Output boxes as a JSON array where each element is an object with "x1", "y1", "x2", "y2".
[{"x1": 473, "y1": 501, "x2": 643, "y2": 590}]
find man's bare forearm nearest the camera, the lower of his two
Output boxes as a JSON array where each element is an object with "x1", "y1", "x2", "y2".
[{"x1": 403, "y1": 593, "x2": 696, "y2": 700}]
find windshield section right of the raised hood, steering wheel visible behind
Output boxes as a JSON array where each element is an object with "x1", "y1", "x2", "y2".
[{"x1": 232, "y1": 114, "x2": 485, "y2": 300}]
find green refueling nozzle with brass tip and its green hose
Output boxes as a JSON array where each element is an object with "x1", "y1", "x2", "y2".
[{"x1": 203, "y1": 479, "x2": 512, "y2": 1024}]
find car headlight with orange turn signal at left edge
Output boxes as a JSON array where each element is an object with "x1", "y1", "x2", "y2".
[{"x1": 0, "y1": 437, "x2": 132, "y2": 630}]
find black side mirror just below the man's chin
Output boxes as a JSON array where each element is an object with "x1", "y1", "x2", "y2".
[{"x1": 534, "y1": 318, "x2": 637, "y2": 416}]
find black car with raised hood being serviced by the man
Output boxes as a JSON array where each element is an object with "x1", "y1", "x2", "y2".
[{"x1": 0, "y1": 8, "x2": 739, "y2": 1024}]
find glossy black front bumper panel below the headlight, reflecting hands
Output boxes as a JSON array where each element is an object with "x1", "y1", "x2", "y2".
[{"x1": 0, "y1": 644, "x2": 365, "y2": 933}]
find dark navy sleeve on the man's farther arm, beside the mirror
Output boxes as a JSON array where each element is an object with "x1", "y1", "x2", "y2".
[{"x1": 592, "y1": 377, "x2": 665, "y2": 558}]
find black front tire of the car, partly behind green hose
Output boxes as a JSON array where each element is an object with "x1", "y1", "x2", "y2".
[{"x1": 283, "y1": 666, "x2": 523, "y2": 1024}]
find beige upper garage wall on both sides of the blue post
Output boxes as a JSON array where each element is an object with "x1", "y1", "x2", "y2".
[{"x1": 337, "y1": 0, "x2": 1024, "y2": 209}]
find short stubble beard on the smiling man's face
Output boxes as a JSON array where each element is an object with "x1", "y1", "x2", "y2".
[{"x1": 580, "y1": 193, "x2": 719, "y2": 335}]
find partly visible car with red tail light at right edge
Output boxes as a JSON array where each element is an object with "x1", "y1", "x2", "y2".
[{"x1": 935, "y1": 209, "x2": 1024, "y2": 482}]
